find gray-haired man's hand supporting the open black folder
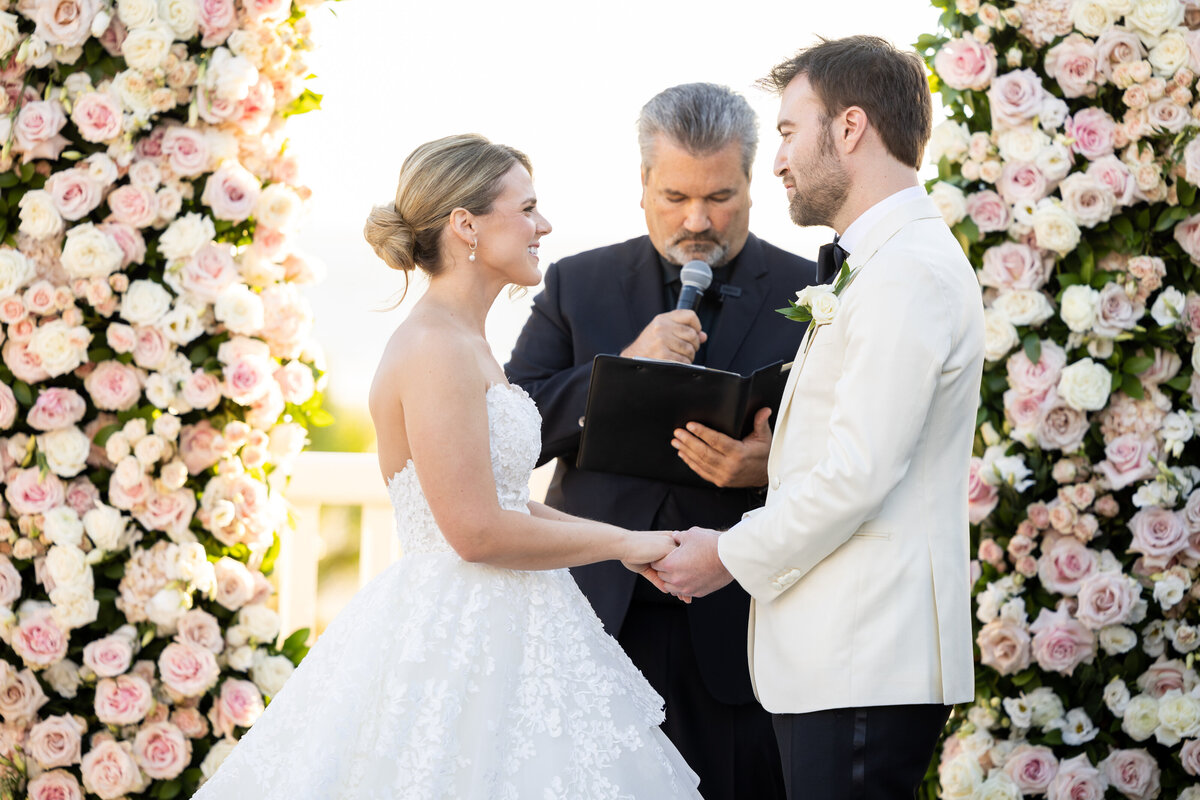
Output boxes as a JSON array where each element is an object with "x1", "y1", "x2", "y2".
[{"x1": 671, "y1": 408, "x2": 770, "y2": 488}]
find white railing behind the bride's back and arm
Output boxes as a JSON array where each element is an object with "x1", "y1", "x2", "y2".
[{"x1": 275, "y1": 452, "x2": 553, "y2": 634}]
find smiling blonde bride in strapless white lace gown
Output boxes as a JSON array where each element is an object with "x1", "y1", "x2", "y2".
[{"x1": 194, "y1": 136, "x2": 700, "y2": 800}]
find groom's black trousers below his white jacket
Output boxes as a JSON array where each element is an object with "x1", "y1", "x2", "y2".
[{"x1": 773, "y1": 705, "x2": 950, "y2": 800}]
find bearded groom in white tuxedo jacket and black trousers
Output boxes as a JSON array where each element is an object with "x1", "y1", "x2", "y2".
[{"x1": 654, "y1": 36, "x2": 984, "y2": 800}]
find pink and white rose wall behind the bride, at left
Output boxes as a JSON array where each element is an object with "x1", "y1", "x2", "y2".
[{"x1": 0, "y1": 0, "x2": 329, "y2": 800}]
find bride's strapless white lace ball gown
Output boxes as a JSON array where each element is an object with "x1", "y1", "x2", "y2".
[{"x1": 194, "y1": 384, "x2": 700, "y2": 800}]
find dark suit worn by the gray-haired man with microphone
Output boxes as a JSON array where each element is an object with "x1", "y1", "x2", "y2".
[{"x1": 505, "y1": 234, "x2": 816, "y2": 800}]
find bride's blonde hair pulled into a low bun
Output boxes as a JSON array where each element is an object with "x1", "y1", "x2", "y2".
[{"x1": 362, "y1": 133, "x2": 533, "y2": 297}]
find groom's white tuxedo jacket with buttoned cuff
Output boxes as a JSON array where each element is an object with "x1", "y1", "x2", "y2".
[{"x1": 719, "y1": 193, "x2": 984, "y2": 714}]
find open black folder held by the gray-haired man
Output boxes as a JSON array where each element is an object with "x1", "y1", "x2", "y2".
[{"x1": 575, "y1": 355, "x2": 792, "y2": 487}]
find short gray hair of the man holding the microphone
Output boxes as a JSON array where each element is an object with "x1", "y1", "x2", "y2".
[{"x1": 637, "y1": 83, "x2": 758, "y2": 175}]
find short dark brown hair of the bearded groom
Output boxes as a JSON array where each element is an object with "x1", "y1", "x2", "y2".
[{"x1": 758, "y1": 36, "x2": 934, "y2": 169}]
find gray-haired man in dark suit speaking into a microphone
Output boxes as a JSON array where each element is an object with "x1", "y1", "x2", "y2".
[{"x1": 505, "y1": 83, "x2": 815, "y2": 800}]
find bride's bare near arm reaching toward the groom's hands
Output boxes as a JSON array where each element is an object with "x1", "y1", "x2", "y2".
[{"x1": 395, "y1": 333, "x2": 674, "y2": 570}]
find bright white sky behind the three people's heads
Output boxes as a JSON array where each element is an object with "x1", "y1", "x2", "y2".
[{"x1": 288, "y1": 0, "x2": 938, "y2": 407}]
